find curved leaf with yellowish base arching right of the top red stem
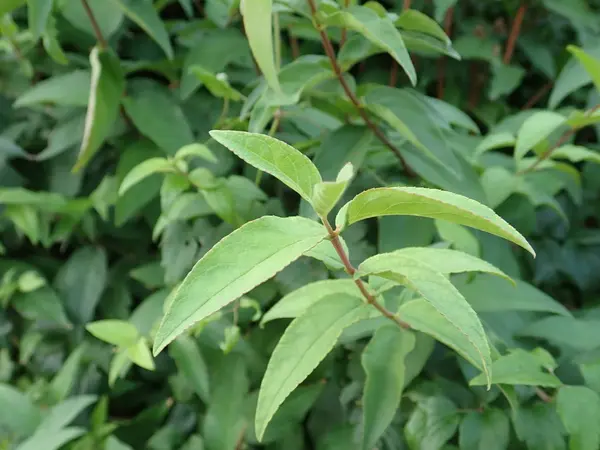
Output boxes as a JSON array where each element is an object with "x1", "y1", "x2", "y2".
[{"x1": 321, "y1": 5, "x2": 417, "y2": 85}]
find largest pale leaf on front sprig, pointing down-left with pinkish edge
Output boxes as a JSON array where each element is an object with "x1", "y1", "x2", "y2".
[{"x1": 154, "y1": 216, "x2": 327, "y2": 355}]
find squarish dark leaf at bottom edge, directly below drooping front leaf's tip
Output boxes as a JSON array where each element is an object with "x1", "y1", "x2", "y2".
[{"x1": 459, "y1": 409, "x2": 510, "y2": 450}]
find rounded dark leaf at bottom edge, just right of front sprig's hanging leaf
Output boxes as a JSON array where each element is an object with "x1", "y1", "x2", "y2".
[{"x1": 404, "y1": 397, "x2": 460, "y2": 450}]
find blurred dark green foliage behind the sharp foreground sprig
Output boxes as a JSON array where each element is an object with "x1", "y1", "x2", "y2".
[{"x1": 0, "y1": 0, "x2": 600, "y2": 450}]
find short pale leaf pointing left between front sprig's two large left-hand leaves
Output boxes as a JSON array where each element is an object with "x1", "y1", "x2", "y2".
[{"x1": 260, "y1": 280, "x2": 362, "y2": 326}]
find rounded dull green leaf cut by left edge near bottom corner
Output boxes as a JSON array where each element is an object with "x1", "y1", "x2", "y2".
[{"x1": 0, "y1": 384, "x2": 41, "y2": 437}]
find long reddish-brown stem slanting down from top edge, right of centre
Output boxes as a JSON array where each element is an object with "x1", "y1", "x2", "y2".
[{"x1": 307, "y1": 0, "x2": 415, "y2": 177}]
